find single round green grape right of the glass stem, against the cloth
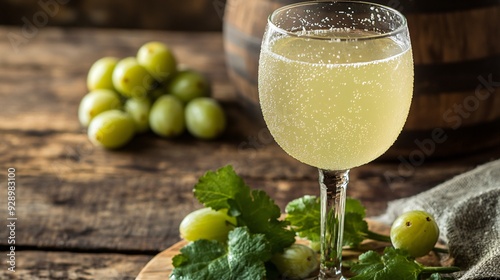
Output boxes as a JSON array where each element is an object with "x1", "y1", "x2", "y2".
[{"x1": 390, "y1": 210, "x2": 439, "y2": 258}]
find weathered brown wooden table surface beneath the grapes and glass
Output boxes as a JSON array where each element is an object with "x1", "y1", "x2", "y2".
[{"x1": 0, "y1": 27, "x2": 500, "y2": 279}]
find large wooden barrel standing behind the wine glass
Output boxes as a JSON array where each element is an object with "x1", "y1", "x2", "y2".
[{"x1": 223, "y1": 0, "x2": 500, "y2": 158}]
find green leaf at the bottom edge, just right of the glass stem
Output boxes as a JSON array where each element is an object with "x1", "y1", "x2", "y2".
[{"x1": 351, "y1": 247, "x2": 423, "y2": 280}]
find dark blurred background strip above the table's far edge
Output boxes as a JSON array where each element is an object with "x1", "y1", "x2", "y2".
[{"x1": 0, "y1": 0, "x2": 225, "y2": 31}]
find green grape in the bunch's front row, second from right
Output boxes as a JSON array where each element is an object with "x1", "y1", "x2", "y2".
[{"x1": 149, "y1": 95, "x2": 185, "y2": 137}]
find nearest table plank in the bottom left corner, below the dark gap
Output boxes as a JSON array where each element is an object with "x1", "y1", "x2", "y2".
[{"x1": 0, "y1": 251, "x2": 151, "y2": 280}]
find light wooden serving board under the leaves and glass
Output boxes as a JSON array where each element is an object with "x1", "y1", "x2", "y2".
[{"x1": 136, "y1": 219, "x2": 450, "y2": 280}]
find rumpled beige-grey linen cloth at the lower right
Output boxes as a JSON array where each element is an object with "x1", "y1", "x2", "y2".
[{"x1": 377, "y1": 159, "x2": 500, "y2": 280}]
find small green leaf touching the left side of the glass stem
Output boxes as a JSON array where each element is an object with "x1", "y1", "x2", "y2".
[{"x1": 285, "y1": 195, "x2": 321, "y2": 242}]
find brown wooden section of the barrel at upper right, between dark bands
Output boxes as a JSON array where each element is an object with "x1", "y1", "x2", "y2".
[{"x1": 406, "y1": 5, "x2": 500, "y2": 65}]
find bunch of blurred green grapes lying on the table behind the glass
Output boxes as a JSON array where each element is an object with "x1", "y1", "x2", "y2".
[{"x1": 78, "y1": 42, "x2": 226, "y2": 149}]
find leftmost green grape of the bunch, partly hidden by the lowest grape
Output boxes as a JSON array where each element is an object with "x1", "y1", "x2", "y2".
[{"x1": 78, "y1": 89, "x2": 122, "y2": 127}]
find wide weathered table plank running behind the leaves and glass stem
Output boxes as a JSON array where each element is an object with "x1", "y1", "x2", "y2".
[{"x1": 0, "y1": 120, "x2": 499, "y2": 251}]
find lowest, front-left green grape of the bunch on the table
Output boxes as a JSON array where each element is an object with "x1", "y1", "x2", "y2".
[{"x1": 88, "y1": 109, "x2": 135, "y2": 149}]
